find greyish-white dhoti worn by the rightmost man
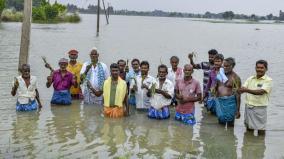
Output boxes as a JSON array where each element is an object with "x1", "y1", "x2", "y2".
[{"x1": 245, "y1": 105, "x2": 267, "y2": 130}]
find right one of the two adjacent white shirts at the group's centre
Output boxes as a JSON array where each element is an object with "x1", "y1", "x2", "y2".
[{"x1": 150, "y1": 78, "x2": 175, "y2": 109}]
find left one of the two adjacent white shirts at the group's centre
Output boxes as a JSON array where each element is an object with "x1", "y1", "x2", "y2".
[{"x1": 130, "y1": 75, "x2": 156, "y2": 109}]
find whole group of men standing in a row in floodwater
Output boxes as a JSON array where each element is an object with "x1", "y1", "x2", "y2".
[{"x1": 11, "y1": 48, "x2": 272, "y2": 135}]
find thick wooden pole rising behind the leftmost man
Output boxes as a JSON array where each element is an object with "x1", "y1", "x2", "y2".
[{"x1": 18, "y1": 0, "x2": 32, "y2": 71}]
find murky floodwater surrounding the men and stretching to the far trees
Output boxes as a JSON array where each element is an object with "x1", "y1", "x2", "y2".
[{"x1": 0, "y1": 15, "x2": 284, "y2": 159}]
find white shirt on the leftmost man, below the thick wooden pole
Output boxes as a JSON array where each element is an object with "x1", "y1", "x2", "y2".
[{"x1": 13, "y1": 76, "x2": 37, "y2": 104}]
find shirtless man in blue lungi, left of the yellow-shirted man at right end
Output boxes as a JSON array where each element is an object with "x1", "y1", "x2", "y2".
[{"x1": 215, "y1": 57, "x2": 241, "y2": 126}]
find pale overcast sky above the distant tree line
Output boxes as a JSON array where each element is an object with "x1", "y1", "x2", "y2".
[{"x1": 51, "y1": 0, "x2": 284, "y2": 16}]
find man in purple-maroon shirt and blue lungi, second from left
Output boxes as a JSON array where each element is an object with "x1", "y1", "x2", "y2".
[{"x1": 46, "y1": 58, "x2": 78, "y2": 105}]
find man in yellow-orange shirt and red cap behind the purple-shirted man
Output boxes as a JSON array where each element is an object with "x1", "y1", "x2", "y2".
[{"x1": 67, "y1": 49, "x2": 83, "y2": 99}]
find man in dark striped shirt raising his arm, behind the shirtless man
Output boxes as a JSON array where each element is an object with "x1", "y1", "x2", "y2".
[{"x1": 188, "y1": 49, "x2": 218, "y2": 104}]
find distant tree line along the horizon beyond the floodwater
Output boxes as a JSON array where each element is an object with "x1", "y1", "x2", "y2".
[{"x1": 67, "y1": 4, "x2": 284, "y2": 21}]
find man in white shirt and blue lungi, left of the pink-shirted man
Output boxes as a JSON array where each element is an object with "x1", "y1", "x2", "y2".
[{"x1": 148, "y1": 65, "x2": 174, "y2": 119}]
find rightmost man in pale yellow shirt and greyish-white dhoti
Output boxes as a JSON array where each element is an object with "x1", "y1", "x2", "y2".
[{"x1": 238, "y1": 60, "x2": 272, "y2": 134}]
